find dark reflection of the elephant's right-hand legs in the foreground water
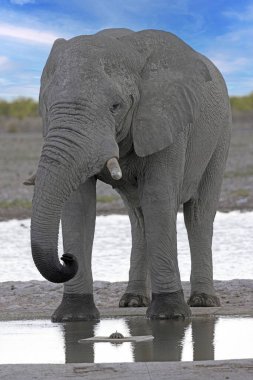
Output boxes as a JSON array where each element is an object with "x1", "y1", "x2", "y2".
[{"x1": 127, "y1": 318, "x2": 216, "y2": 362}]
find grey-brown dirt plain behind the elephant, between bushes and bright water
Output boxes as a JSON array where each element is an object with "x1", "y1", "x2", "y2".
[{"x1": 0, "y1": 112, "x2": 253, "y2": 220}]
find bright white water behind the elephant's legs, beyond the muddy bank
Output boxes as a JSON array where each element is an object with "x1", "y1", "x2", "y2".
[{"x1": 0, "y1": 211, "x2": 253, "y2": 282}]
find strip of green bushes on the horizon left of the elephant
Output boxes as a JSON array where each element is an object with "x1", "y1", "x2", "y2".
[{"x1": 0, "y1": 98, "x2": 39, "y2": 119}]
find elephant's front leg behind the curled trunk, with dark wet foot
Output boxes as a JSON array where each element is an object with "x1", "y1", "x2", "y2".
[{"x1": 52, "y1": 178, "x2": 99, "y2": 322}]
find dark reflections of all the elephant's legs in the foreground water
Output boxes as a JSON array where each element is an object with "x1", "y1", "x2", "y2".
[{"x1": 63, "y1": 318, "x2": 216, "y2": 363}]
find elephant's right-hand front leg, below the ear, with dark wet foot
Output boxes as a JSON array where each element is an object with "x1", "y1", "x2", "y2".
[{"x1": 142, "y1": 197, "x2": 191, "y2": 319}]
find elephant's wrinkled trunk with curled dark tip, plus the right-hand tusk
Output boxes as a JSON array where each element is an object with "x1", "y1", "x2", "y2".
[{"x1": 31, "y1": 121, "x2": 121, "y2": 283}]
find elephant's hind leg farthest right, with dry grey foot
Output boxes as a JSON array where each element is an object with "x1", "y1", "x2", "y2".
[{"x1": 184, "y1": 130, "x2": 229, "y2": 307}]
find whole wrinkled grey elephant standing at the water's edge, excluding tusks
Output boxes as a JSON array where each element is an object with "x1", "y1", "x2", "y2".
[{"x1": 31, "y1": 29, "x2": 231, "y2": 321}]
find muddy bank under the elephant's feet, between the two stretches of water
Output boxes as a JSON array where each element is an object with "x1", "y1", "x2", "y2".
[{"x1": 0, "y1": 279, "x2": 253, "y2": 321}]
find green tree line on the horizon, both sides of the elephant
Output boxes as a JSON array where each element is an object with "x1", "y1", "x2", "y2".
[{"x1": 0, "y1": 92, "x2": 253, "y2": 119}]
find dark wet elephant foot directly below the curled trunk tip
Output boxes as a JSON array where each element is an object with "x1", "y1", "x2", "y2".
[{"x1": 51, "y1": 293, "x2": 100, "y2": 322}]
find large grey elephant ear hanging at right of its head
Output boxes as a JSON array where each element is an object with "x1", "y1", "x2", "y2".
[{"x1": 133, "y1": 60, "x2": 211, "y2": 157}]
